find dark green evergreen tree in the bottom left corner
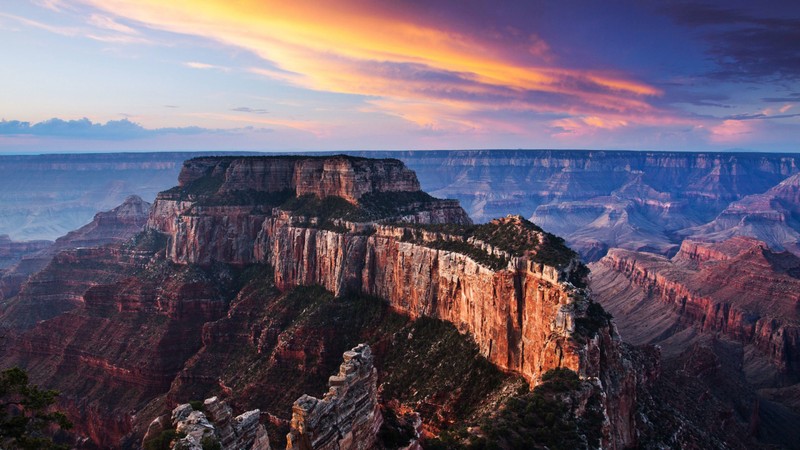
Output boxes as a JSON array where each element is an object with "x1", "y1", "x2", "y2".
[{"x1": 0, "y1": 367, "x2": 72, "y2": 450}]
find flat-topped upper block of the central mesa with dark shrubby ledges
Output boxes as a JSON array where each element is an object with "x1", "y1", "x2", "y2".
[{"x1": 148, "y1": 156, "x2": 472, "y2": 265}]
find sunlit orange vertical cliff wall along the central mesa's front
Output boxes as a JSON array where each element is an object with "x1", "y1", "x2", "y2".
[{"x1": 256, "y1": 219, "x2": 582, "y2": 383}]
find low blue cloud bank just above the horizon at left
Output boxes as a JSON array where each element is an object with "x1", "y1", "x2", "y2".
[{"x1": 0, "y1": 118, "x2": 212, "y2": 141}]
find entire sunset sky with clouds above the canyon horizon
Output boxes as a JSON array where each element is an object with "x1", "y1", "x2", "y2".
[{"x1": 0, "y1": 0, "x2": 800, "y2": 154}]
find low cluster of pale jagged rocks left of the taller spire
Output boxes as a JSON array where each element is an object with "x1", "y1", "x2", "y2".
[{"x1": 164, "y1": 397, "x2": 270, "y2": 450}]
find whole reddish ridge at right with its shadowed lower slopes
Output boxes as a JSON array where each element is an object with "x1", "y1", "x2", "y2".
[{"x1": 590, "y1": 236, "x2": 800, "y2": 448}]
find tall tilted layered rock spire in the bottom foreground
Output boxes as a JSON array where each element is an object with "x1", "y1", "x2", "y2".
[{"x1": 286, "y1": 344, "x2": 383, "y2": 450}]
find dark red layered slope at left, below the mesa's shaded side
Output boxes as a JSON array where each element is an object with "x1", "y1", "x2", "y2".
[{"x1": 0, "y1": 247, "x2": 236, "y2": 448}]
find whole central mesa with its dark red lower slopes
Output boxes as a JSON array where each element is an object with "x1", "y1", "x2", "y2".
[{"x1": 0, "y1": 156, "x2": 657, "y2": 448}]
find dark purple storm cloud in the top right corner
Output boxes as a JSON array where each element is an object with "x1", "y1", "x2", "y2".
[{"x1": 664, "y1": 2, "x2": 800, "y2": 81}]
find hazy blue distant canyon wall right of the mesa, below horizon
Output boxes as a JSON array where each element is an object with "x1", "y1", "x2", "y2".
[{"x1": 354, "y1": 150, "x2": 800, "y2": 261}]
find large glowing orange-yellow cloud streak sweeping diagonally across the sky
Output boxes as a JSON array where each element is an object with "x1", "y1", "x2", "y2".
[{"x1": 75, "y1": 0, "x2": 661, "y2": 128}]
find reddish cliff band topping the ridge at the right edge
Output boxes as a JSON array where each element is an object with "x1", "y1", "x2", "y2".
[{"x1": 594, "y1": 237, "x2": 800, "y2": 376}]
